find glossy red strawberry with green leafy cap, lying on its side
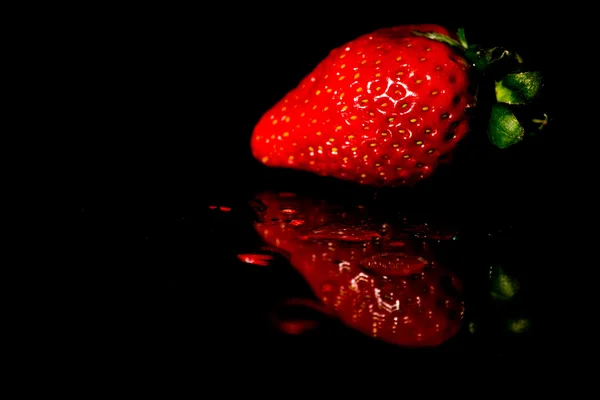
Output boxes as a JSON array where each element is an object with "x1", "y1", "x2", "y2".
[{"x1": 250, "y1": 24, "x2": 542, "y2": 186}]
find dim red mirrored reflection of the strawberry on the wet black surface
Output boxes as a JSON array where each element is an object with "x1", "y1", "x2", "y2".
[{"x1": 255, "y1": 192, "x2": 464, "y2": 347}]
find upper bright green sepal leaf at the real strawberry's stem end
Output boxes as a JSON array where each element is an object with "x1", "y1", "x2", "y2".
[{"x1": 495, "y1": 71, "x2": 544, "y2": 104}]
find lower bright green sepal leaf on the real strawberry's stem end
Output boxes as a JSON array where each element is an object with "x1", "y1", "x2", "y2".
[{"x1": 488, "y1": 103, "x2": 525, "y2": 149}]
